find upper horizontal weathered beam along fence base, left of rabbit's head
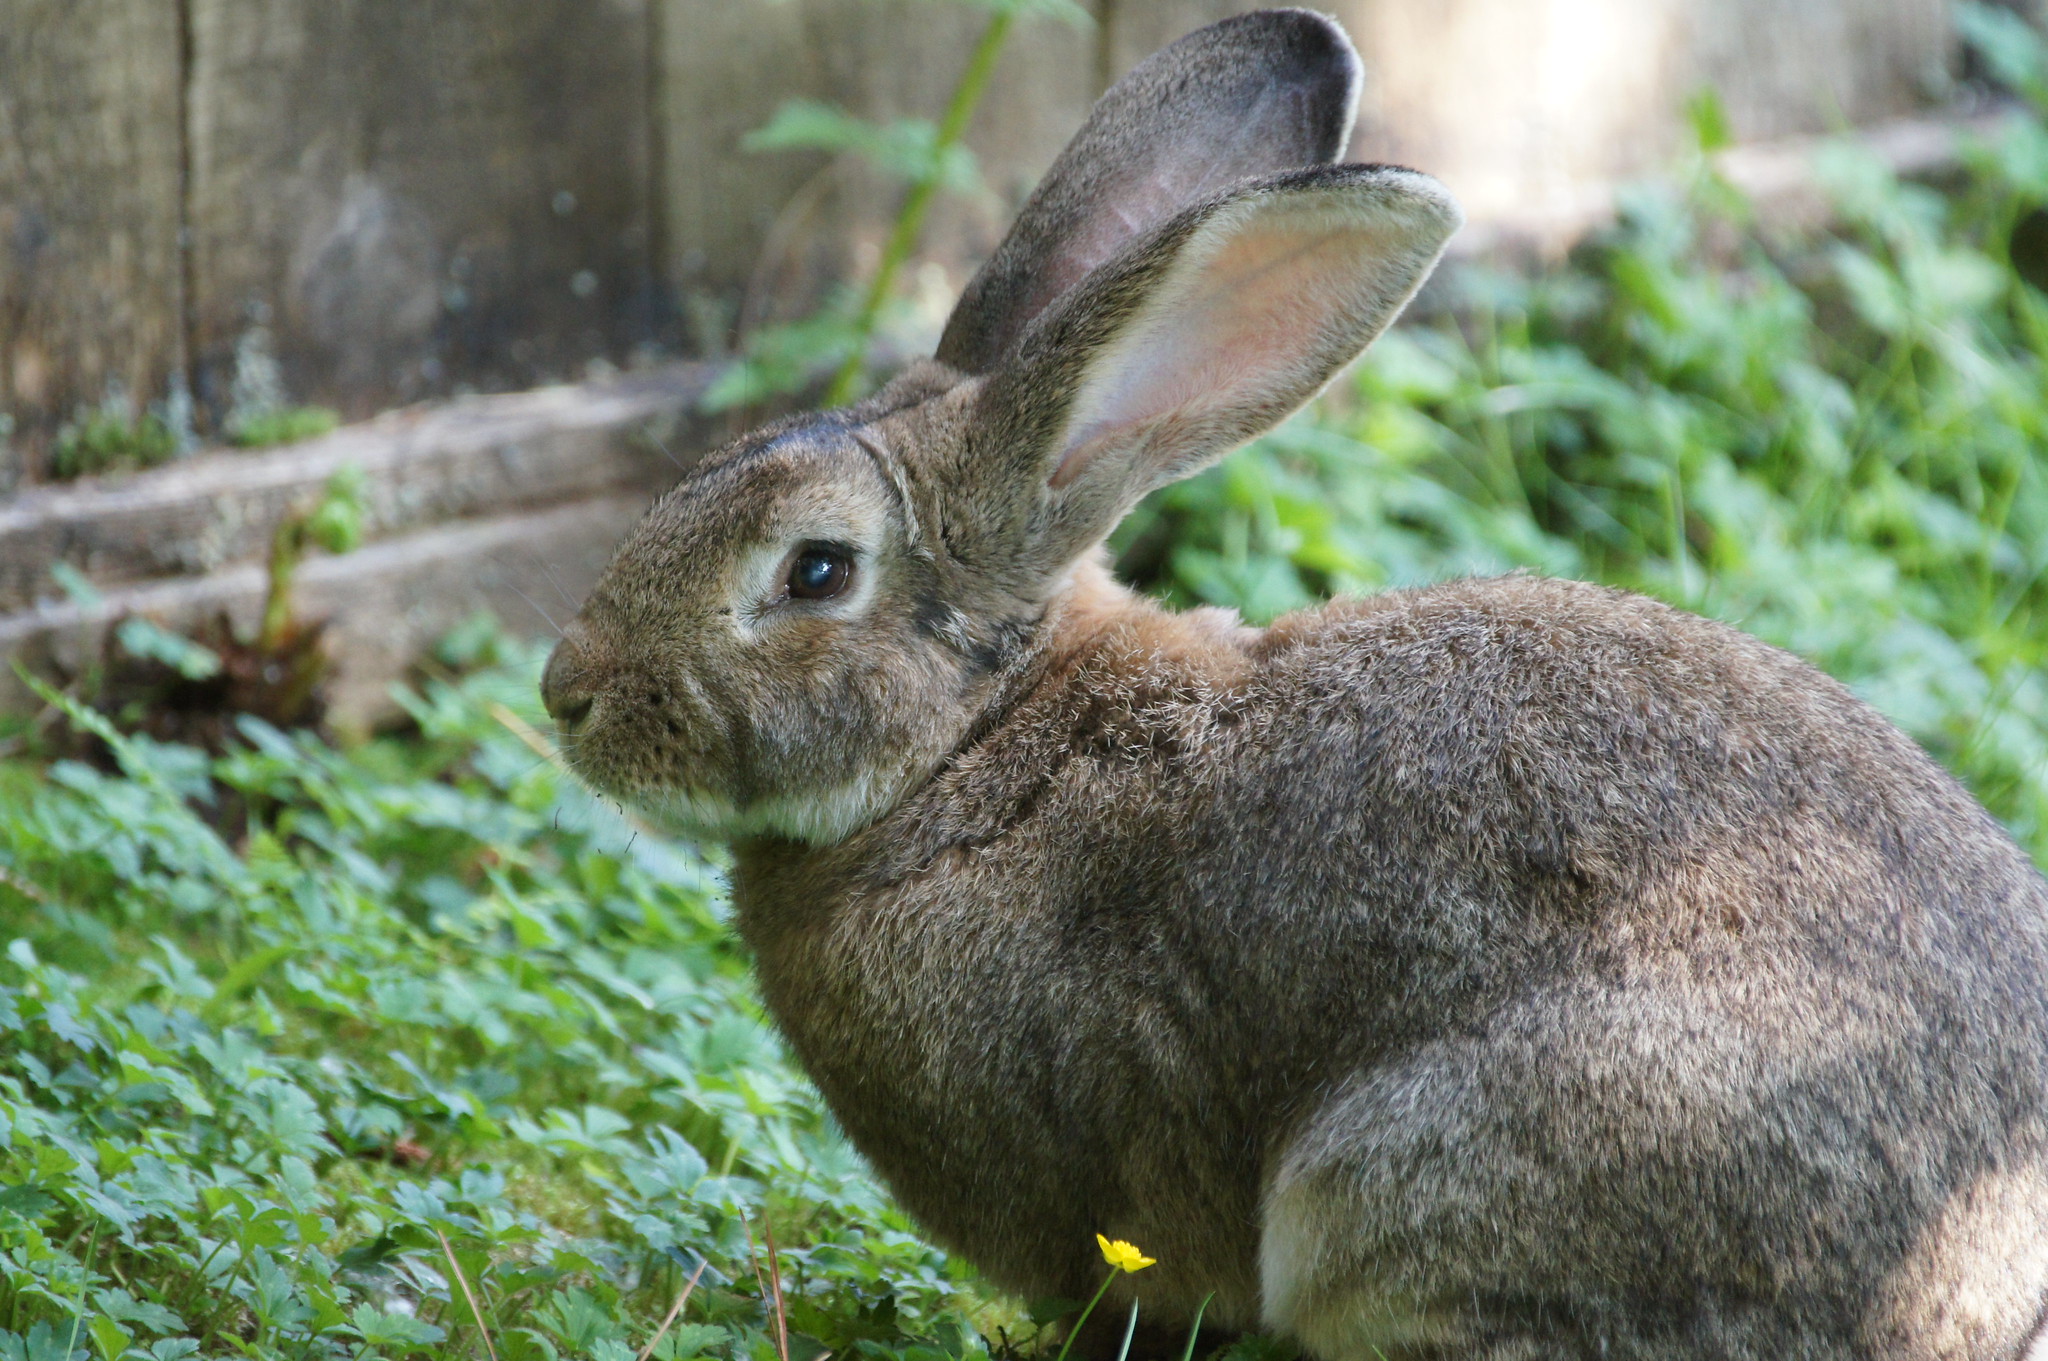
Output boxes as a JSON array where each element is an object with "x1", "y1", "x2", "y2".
[{"x1": 0, "y1": 364, "x2": 709, "y2": 612}]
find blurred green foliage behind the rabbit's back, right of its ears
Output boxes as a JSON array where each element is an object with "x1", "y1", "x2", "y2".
[{"x1": 1116, "y1": 61, "x2": 2048, "y2": 862}]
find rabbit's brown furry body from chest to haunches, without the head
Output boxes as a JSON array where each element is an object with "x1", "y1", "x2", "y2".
[{"x1": 737, "y1": 577, "x2": 2048, "y2": 1355}]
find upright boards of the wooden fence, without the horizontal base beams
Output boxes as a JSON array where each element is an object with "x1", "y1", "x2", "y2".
[{"x1": 0, "y1": 0, "x2": 1952, "y2": 491}]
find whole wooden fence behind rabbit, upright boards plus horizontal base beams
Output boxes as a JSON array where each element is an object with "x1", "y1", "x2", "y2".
[{"x1": 0, "y1": 0, "x2": 2015, "y2": 725}]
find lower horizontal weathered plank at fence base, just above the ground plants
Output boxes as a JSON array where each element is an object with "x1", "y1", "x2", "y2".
[{"x1": 0, "y1": 495, "x2": 647, "y2": 727}]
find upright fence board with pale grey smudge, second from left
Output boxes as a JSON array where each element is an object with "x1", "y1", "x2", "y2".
[{"x1": 187, "y1": 0, "x2": 659, "y2": 422}]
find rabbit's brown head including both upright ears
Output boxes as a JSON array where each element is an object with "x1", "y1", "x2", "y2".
[{"x1": 543, "y1": 10, "x2": 1460, "y2": 843}]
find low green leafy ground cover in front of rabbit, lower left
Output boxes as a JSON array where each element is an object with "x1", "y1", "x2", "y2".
[{"x1": 0, "y1": 657, "x2": 981, "y2": 1361}]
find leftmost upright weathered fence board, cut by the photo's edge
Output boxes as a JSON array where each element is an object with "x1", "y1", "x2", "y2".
[{"x1": 0, "y1": 0, "x2": 180, "y2": 491}]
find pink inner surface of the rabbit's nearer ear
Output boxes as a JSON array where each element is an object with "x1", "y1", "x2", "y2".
[{"x1": 1051, "y1": 213, "x2": 1386, "y2": 487}]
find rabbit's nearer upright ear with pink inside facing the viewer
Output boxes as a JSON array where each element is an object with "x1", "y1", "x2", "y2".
[{"x1": 963, "y1": 166, "x2": 1462, "y2": 573}]
